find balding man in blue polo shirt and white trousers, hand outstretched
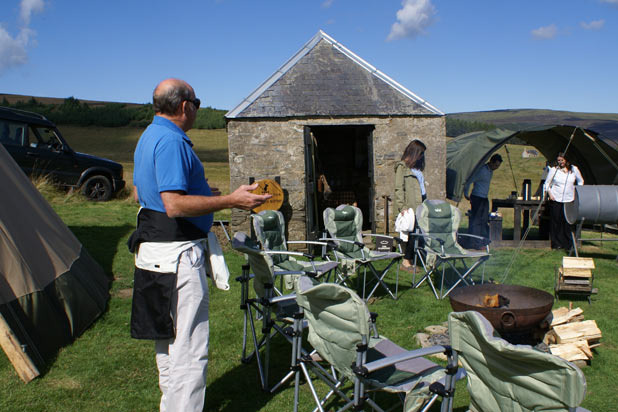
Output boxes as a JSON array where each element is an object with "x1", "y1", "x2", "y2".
[{"x1": 129, "y1": 79, "x2": 270, "y2": 412}]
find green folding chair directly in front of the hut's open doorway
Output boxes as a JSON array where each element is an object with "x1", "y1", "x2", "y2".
[{"x1": 320, "y1": 205, "x2": 403, "y2": 299}]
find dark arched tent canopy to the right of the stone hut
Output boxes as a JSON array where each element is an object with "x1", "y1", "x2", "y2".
[{"x1": 446, "y1": 125, "x2": 618, "y2": 202}]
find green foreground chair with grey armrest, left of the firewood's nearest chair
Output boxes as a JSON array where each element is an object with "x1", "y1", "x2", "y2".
[{"x1": 296, "y1": 278, "x2": 464, "y2": 412}]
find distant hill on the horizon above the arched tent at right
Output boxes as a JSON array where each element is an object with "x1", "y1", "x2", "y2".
[{"x1": 446, "y1": 109, "x2": 618, "y2": 141}]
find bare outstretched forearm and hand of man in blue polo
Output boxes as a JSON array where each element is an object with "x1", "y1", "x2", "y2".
[{"x1": 161, "y1": 183, "x2": 272, "y2": 218}]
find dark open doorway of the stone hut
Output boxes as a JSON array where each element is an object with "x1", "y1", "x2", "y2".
[{"x1": 305, "y1": 125, "x2": 375, "y2": 239}]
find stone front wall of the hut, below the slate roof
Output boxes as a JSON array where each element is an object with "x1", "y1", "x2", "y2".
[{"x1": 227, "y1": 116, "x2": 446, "y2": 240}]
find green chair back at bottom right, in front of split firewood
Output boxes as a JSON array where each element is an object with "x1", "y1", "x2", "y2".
[{"x1": 448, "y1": 311, "x2": 589, "y2": 412}]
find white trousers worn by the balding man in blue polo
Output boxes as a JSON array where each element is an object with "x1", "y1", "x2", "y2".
[{"x1": 155, "y1": 245, "x2": 209, "y2": 412}]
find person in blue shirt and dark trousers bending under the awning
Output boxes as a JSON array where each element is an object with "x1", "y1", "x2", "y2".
[{"x1": 464, "y1": 154, "x2": 502, "y2": 249}]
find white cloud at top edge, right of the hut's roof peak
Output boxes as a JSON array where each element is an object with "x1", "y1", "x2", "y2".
[{"x1": 386, "y1": 0, "x2": 436, "y2": 41}]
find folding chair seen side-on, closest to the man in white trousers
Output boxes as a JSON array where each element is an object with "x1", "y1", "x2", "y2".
[{"x1": 232, "y1": 232, "x2": 320, "y2": 392}]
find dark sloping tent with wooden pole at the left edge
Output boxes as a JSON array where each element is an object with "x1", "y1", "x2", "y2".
[{"x1": 0, "y1": 145, "x2": 110, "y2": 381}]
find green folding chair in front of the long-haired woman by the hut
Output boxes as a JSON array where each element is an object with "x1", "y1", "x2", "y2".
[{"x1": 412, "y1": 200, "x2": 490, "y2": 299}]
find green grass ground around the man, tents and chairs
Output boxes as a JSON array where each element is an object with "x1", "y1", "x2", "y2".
[{"x1": 0, "y1": 127, "x2": 618, "y2": 412}]
